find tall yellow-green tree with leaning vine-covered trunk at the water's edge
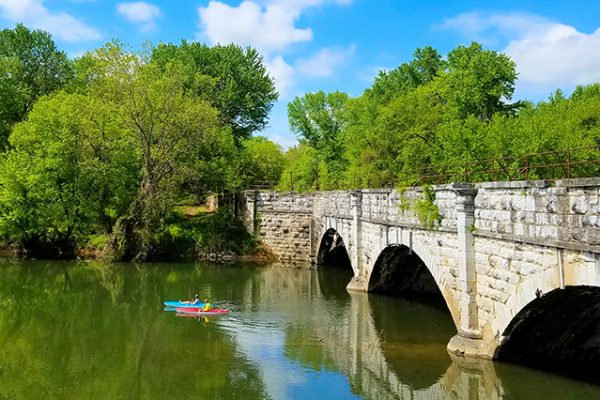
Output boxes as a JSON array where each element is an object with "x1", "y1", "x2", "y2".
[{"x1": 79, "y1": 44, "x2": 230, "y2": 260}]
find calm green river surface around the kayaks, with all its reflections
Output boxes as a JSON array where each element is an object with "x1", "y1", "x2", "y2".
[{"x1": 0, "y1": 260, "x2": 600, "y2": 399}]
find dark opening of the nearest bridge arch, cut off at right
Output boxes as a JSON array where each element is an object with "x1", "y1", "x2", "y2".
[{"x1": 494, "y1": 286, "x2": 600, "y2": 378}]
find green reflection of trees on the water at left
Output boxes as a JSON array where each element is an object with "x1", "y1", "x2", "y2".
[{"x1": 0, "y1": 262, "x2": 267, "y2": 399}]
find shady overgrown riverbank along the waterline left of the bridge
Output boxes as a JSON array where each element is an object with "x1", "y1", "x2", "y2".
[{"x1": 0, "y1": 206, "x2": 268, "y2": 263}]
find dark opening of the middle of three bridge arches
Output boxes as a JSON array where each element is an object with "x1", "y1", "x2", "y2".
[{"x1": 367, "y1": 244, "x2": 445, "y2": 305}]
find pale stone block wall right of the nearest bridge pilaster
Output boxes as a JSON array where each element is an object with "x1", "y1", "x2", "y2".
[{"x1": 475, "y1": 178, "x2": 600, "y2": 248}]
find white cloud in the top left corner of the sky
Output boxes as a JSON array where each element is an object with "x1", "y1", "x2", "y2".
[{"x1": 0, "y1": 0, "x2": 102, "y2": 42}]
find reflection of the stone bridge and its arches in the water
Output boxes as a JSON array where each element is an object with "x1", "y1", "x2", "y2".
[{"x1": 237, "y1": 268, "x2": 486, "y2": 399}]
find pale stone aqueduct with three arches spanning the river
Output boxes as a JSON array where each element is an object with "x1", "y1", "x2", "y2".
[{"x1": 238, "y1": 178, "x2": 600, "y2": 358}]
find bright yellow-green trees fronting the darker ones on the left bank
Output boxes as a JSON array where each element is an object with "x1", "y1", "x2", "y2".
[{"x1": 0, "y1": 43, "x2": 235, "y2": 260}]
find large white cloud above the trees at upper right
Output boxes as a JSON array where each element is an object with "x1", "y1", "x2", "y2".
[{"x1": 440, "y1": 13, "x2": 600, "y2": 94}]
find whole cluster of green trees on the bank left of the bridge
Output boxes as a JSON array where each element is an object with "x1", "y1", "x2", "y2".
[{"x1": 0, "y1": 25, "x2": 283, "y2": 260}]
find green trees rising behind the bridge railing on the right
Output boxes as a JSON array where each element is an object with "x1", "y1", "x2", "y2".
[{"x1": 279, "y1": 43, "x2": 600, "y2": 190}]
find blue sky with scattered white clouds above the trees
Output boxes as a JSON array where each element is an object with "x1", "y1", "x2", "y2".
[{"x1": 0, "y1": 0, "x2": 600, "y2": 147}]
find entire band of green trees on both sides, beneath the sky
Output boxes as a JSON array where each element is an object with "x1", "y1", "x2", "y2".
[{"x1": 0, "y1": 25, "x2": 600, "y2": 260}]
